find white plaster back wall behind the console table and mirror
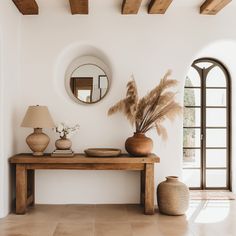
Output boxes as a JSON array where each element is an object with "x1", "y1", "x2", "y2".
[{"x1": 16, "y1": 0, "x2": 236, "y2": 203}]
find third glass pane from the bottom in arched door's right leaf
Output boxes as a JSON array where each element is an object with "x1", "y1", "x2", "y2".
[{"x1": 206, "y1": 129, "x2": 226, "y2": 147}]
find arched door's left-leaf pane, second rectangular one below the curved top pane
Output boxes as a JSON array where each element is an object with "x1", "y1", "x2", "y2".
[{"x1": 184, "y1": 107, "x2": 201, "y2": 127}]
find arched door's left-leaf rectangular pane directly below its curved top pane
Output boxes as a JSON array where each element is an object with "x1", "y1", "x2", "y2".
[{"x1": 184, "y1": 88, "x2": 201, "y2": 106}]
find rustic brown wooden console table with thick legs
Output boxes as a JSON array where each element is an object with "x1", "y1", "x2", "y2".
[{"x1": 10, "y1": 154, "x2": 160, "y2": 215}]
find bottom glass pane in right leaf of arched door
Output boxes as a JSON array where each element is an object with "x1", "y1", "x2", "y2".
[{"x1": 206, "y1": 170, "x2": 227, "y2": 188}]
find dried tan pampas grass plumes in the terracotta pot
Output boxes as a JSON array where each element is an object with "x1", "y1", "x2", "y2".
[{"x1": 108, "y1": 71, "x2": 182, "y2": 139}]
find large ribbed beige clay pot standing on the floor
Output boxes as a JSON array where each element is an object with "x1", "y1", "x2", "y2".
[{"x1": 157, "y1": 176, "x2": 189, "y2": 216}]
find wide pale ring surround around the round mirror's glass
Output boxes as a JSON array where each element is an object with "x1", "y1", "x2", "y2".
[{"x1": 65, "y1": 56, "x2": 111, "y2": 105}]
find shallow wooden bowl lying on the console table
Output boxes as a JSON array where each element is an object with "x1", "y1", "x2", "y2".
[{"x1": 84, "y1": 148, "x2": 121, "y2": 157}]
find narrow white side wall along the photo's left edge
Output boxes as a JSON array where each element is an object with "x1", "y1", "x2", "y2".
[{"x1": 0, "y1": 0, "x2": 20, "y2": 218}]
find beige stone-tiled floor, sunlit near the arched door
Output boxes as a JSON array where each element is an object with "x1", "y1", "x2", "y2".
[{"x1": 0, "y1": 200, "x2": 236, "y2": 236}]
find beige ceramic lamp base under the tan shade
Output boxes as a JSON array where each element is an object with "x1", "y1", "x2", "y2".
[{"x1": 26, "y1": 128, "x2": 50, "y2": 156}]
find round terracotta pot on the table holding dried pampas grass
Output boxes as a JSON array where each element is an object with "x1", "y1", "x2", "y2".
[{"x1": 125, "y1": 133, "x2": 153, "y2": 156}]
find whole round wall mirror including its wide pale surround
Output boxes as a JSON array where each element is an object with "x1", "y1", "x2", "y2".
[{"x1": 66, "y1": 57, "x2": 109, "y2": 104}]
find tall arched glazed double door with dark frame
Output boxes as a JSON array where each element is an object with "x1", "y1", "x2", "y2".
[{"x1": 183, "y1": 58, "x2": 231, "y2": 189}]
